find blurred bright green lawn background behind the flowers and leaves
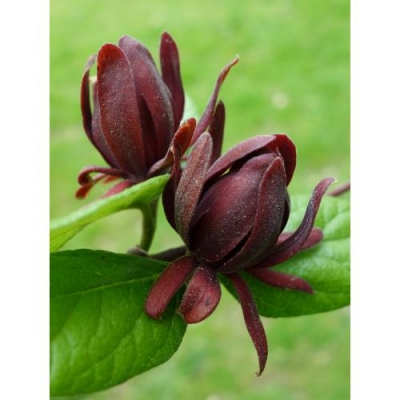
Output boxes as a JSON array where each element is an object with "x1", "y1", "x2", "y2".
[{"x1": 50, "y1": 0, "x2": 350, "y2": 400}]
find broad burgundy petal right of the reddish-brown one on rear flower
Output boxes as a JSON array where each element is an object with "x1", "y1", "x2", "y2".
[{"x1": 118, "y1": 36, "x2": 175, "y2": 164}]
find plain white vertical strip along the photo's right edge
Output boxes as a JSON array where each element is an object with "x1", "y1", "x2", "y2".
[{"x1": 351, "y1": 0, "x2": 400, "y2": 400}]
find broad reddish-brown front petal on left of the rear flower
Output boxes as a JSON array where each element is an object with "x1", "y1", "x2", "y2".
[{"x1": 97, "y1": 44, "x2": 147, "y2": 180}]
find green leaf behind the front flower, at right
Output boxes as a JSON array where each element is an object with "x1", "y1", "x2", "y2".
[{"x1": 221, "y1": 196, "x2": 350, "y2": 317}]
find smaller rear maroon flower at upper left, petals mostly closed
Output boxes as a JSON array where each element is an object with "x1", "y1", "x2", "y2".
[{"x1": 76, "y1": 33, "x2": 237, "y2": 198}]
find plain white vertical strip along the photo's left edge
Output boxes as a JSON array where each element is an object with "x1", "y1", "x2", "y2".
[{"x1": 0, "y1": 1, "x2": 49, "y2": 399}]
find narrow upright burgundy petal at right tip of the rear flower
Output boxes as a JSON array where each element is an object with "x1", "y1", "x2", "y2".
[{"x1": 160, "y1": 32, "x2": 185, "y2": 130}]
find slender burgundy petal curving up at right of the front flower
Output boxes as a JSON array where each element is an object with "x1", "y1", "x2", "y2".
[{"x1": 255, "y1": 178, "x2": 335, "y2": 268}]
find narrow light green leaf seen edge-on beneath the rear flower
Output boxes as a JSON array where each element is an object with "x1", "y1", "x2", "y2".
[{"x1": 50, "y1": 175, "x2": 169, "y2": 251}]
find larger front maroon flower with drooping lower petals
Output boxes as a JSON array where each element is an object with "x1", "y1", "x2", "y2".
[{"x1": 146, "y1": 133, "x2": 333, "y2": 374}]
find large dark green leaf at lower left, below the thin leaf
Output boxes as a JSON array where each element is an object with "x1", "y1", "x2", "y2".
[{"x1": 50, "y1": 250, "x2": 186, "y2": 396}]
